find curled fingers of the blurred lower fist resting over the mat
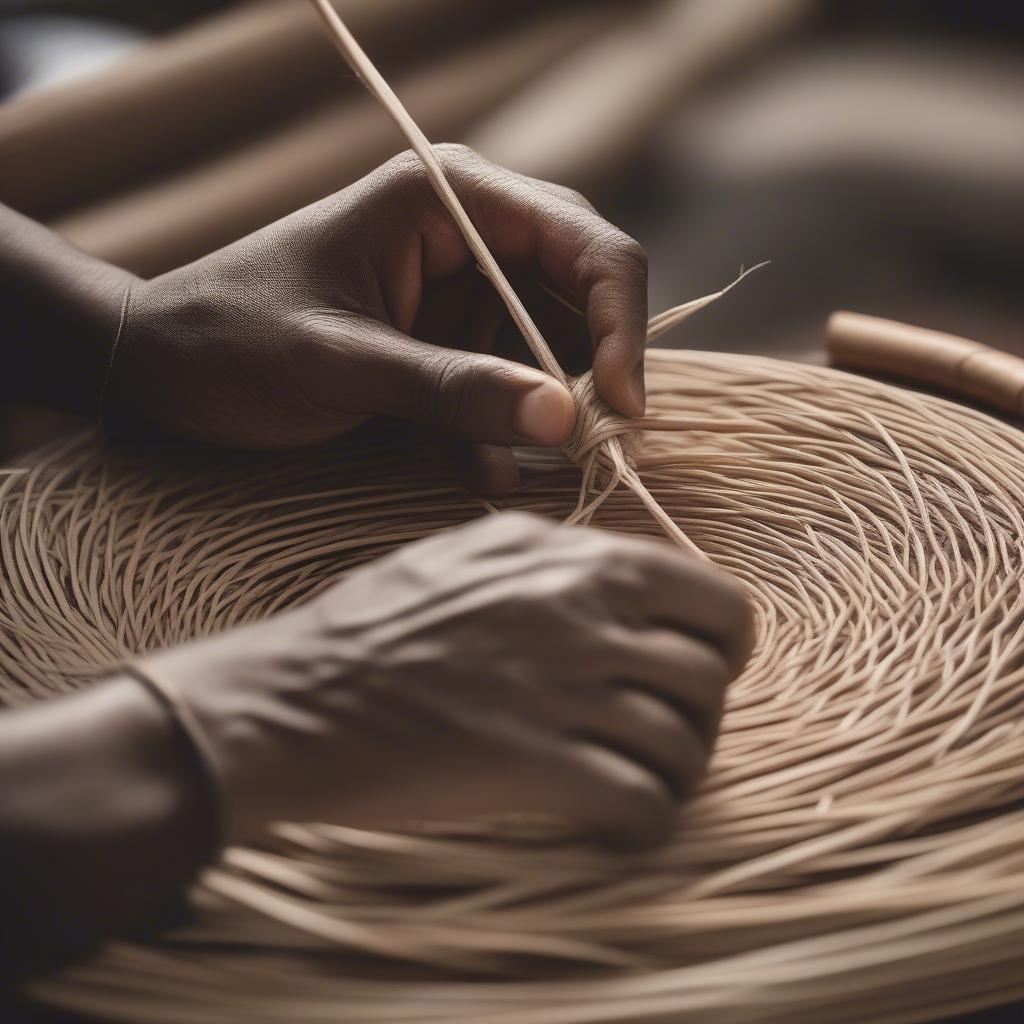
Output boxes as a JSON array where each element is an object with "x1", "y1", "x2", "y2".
[{"x1": 544, "y1": 538, "x2": 753, "y2": 847}]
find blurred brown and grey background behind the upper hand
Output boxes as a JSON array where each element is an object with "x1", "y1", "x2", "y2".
[{"x1": 0, "y1": 0, "x2": 1024, "y2": 359}]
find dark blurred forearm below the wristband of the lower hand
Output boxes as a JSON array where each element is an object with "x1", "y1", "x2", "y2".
[{"x1": 0, "y1": 676, "x2": 216, "y2": 975}]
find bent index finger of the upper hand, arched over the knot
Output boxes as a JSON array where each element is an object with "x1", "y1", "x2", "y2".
[{"x1": 387, "y1": 145, "x2": 647, "y2": 416}]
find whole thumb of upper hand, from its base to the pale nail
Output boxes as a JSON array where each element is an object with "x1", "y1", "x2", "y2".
[{"x1": 299, "y1": 313, "x2": 575, "y2": 445}]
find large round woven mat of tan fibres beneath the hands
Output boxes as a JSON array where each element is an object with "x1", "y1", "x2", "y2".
[{"x1": 0, "y1": 350, "x2": 1024, "y2": 1024}]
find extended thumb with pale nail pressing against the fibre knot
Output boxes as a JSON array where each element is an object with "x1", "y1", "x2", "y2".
[{"x1": 335, "y1": 313, "x2": 575, "y2": 445}]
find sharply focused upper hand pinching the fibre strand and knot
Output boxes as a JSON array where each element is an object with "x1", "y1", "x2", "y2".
[{"x1": 109, "y1": 145, "x2": 646, "y2": 490}]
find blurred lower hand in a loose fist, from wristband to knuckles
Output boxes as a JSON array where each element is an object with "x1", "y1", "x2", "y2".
[{"x1": 136, "y1": 514, "x2": 751, "y2": 845}]
